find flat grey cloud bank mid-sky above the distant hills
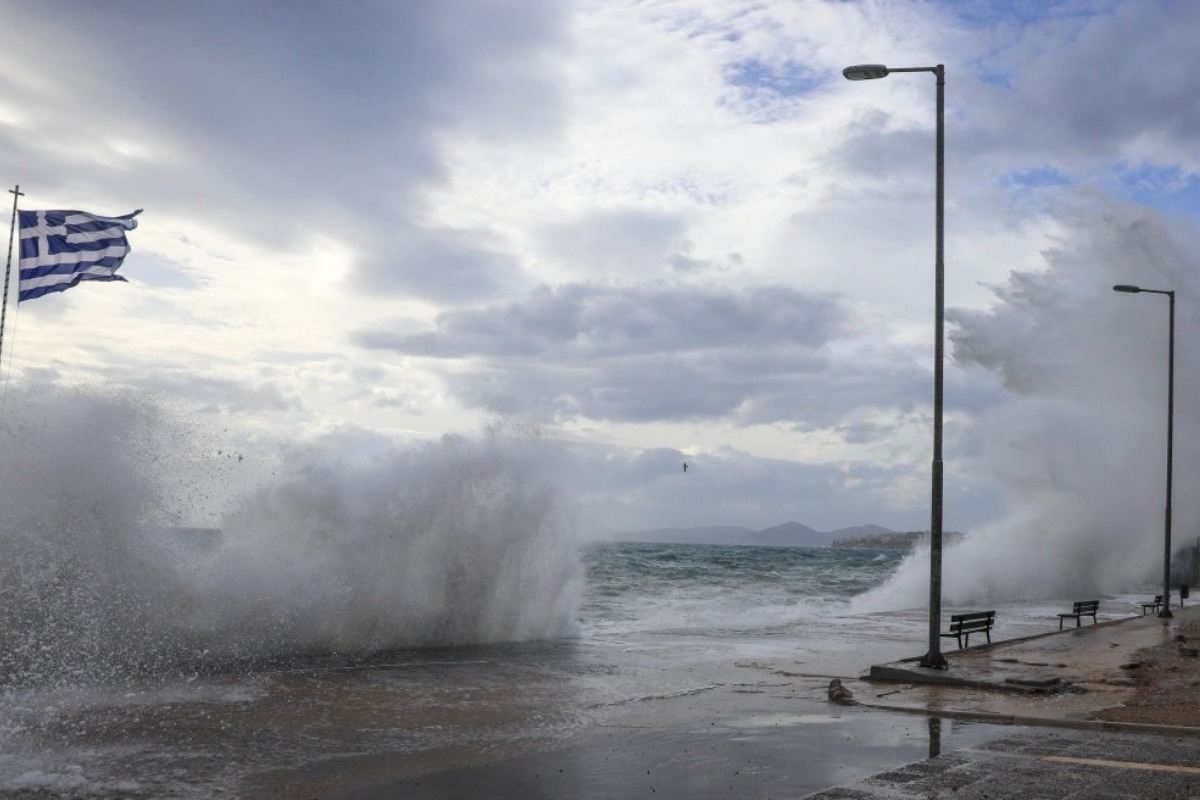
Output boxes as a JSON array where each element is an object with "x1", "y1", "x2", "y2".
[{"x1": 354, "y1": 284, "x2": 865, "y2": 422}]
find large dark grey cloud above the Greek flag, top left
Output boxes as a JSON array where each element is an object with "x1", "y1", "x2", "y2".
[{"x1": 0, "y1": 0, "x2": 563, "y2": 291}]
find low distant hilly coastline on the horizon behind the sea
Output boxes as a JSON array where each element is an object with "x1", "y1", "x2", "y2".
[{"x1": 599, "y1": 522, "x2": 962, "y2": 551}]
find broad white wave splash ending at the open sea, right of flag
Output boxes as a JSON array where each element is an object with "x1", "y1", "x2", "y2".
[{"x1": 192, "y1": 424, "x2": 581, "y2": 655}]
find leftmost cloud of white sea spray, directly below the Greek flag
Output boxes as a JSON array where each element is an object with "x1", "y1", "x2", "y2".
[{"x1": 0, "y1": 386, "x2": 187, "y2": 685}]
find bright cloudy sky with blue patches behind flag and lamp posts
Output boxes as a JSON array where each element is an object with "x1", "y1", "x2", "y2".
[{"x1": 0, "y1": 0, "x2": 1200, "y2": 530}]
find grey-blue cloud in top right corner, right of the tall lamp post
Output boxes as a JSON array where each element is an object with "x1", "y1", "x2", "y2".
[{"x1": 947, "y1": 0, "x2": 1200, "y2": 182}]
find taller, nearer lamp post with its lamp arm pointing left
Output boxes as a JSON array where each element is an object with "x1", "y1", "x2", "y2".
[{"x1": 841, "y1": 64, "x2": 947, "y2": 669}]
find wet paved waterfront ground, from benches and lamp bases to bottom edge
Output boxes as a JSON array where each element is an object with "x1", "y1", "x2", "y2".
[{"x1": 326, "y1": 607, "x2": 1200, "y2": 800}]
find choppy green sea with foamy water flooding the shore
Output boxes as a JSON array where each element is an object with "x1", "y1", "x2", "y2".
[{"x1": 0, "y1": 533, "x2": 1138, "y2": 799}]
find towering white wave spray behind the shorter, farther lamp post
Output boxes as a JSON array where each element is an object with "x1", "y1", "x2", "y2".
[{"x1": 857, "y1": 204, "x2": 1200, "y2": 608}]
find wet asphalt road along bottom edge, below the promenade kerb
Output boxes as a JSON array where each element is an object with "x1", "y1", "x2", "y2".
[{"x1": 336, "y1": 715, "x2": 1200, "y2": 800}]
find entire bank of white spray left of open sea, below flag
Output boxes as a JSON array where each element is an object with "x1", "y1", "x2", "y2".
[{"x1": 0, "y1": 386, "x2": 581, "y2": 688}]
